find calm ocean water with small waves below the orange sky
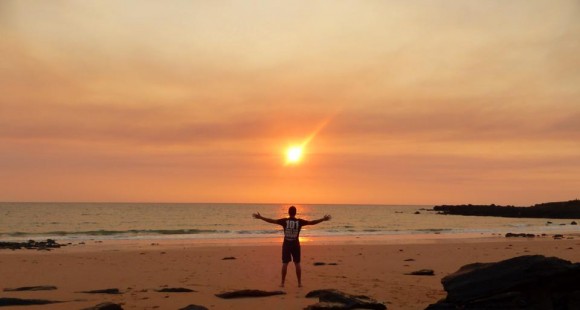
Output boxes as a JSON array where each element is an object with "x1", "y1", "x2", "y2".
[{"x1": 0, "y1": 203, "x2": 579, "y2": 241}]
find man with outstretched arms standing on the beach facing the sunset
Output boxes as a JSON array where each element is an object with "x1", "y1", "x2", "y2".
[{"x1": 253, "y1": 206, "x2": 331, "y2": 287}]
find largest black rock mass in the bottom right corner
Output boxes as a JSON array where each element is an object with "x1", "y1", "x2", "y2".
[{"x1": 427, "y1": 255, "x2": 580, "y2": 310}]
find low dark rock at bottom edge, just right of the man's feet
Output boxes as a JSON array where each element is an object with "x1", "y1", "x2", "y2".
[{"x1": 306, "y1": 289, "x2": 387, "y2": 310}]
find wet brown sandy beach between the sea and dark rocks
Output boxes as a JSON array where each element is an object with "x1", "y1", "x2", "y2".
[{"x1": 0, "y1": 236, "x2": 580, "y2": 309}]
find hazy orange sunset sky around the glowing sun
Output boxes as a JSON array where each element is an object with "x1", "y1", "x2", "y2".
[{"x1": 0, "y1": 0, "x2": 580, "y2": 205}]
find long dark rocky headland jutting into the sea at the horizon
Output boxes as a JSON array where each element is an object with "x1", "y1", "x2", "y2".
[{"x1": 433, "y1": 199, "x2": 580, "y2": 219}]
